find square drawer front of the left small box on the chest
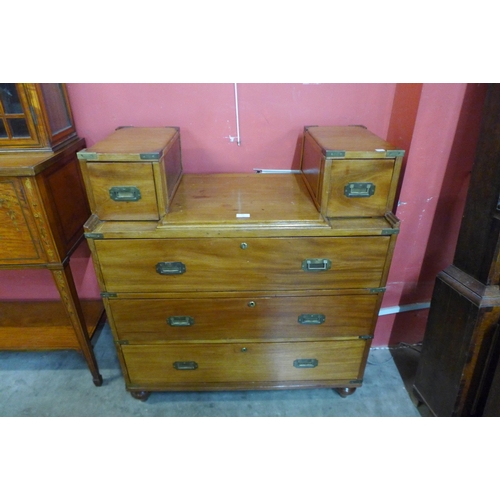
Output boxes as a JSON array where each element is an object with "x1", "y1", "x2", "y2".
[{"x1": 87, "y1": 162, "x2": 159, "y2": 220}]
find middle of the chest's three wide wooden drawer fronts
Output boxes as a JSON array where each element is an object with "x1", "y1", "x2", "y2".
[{"x1": 109, "y1": 294, "x2": 378, "y2": 343}]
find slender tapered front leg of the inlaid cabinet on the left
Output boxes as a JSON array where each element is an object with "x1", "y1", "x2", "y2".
[{"x1": 51, "y1": 260, "x2": 102, "y2": 387}]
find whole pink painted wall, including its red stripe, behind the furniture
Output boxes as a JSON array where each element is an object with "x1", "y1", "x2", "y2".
[{"x1": 0, "y1": 83, "x2": 486, "y2": 346}]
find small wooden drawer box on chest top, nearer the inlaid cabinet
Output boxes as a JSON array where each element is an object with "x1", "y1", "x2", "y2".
[{"x1": 77, "y1": 127, "x2": 182, "y2": 220}]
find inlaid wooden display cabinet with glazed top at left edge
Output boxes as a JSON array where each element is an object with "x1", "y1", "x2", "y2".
[{"x1": 0, "y1": 83, "x2": 104, "y2": 386}]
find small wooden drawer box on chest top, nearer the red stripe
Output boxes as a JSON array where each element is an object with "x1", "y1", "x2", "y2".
[{"x1": 301, "y1": 126, "x2": 404, "y2": 217}]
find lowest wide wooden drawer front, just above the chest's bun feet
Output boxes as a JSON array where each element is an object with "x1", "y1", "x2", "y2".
[{"x1": 121, "y1": 340, "x2": 367, "y2": 388}]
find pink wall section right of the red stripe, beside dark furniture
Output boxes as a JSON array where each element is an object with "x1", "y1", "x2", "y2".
[{"x1": 374, "y1": 84, "x2": 487, "y2": 345}]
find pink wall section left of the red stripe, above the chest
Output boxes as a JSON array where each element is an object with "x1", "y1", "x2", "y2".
[{"x1": 68, "y1": 83, "x2": 396, "y2": 173}]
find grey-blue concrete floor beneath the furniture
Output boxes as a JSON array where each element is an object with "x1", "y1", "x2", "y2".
[{"x1": 0, "y1": 323, "x2": 428, "y2": 417}]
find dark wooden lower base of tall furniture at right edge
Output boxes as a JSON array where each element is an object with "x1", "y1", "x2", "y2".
[{"x1": 415, "y1": 269, "x2": 500, "y2": 417}]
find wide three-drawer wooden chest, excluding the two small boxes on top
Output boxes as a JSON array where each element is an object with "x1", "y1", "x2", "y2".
[{"x1": 85, "y1": 174, "x2": 399, "y2": 400}]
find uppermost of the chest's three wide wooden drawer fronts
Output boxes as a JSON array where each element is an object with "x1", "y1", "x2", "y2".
[{"x1": 95, "y1": 236, "x2": 389, "y2": 292}]
